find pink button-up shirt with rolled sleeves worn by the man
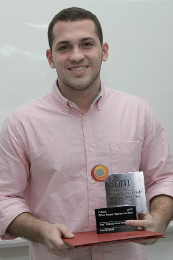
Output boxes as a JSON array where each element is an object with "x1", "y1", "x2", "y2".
[{"x1": 0, "y1": 80, "x2": 173, "y2": 260}]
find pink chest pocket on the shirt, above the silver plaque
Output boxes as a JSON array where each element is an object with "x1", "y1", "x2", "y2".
[{"x1": 109, "y1": 141, "x2": 142, "y2": 173}]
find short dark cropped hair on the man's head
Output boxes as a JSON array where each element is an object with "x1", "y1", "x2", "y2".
[{"x1": 48, "y1": 7, "x2": 103, "y2": 50}]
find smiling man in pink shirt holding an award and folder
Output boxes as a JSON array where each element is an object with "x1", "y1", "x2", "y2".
[{"x1": 0, "y1": 8, "x2": 173, "y2": 260}]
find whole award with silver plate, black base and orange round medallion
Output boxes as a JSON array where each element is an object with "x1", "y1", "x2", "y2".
[{"x1": 91, "y1": 168, "x2": 147, "y2": 234}]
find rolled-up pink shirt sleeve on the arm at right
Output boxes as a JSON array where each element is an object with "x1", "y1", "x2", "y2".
[{"x1": 140, "y1": 104, "x2": 173, "y2": 204}]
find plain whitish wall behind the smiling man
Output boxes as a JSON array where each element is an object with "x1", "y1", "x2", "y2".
[{"x1": 0, "y1": 0, "x2": 173, "y2": 260}]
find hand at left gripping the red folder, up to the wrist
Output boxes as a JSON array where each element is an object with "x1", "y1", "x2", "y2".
[{"x1": 43, "y1": 224, "x2": 74, "y2": 256}]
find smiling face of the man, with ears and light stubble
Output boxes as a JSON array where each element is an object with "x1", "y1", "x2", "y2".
[{"x1": 47, "y1": 20, "x2": 108, "y2": 90}]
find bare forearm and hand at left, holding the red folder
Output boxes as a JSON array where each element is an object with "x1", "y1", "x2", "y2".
[{"x1": 7, "y1": 212, "x2": 74, "y2": 255}]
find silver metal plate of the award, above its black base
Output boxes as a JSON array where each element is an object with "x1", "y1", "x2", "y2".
[{"x1": 105, "y1": 172, "x2": 148, "y2": 213}]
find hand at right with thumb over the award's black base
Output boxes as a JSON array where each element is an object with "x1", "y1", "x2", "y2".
[{"x1": 126, "y1": 214, "x2": 163, "y2": 245}]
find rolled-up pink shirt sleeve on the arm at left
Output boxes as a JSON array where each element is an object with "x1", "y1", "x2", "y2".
[{"x1": 0, "y1": 119, "x2": 30, "y2": 239}]
